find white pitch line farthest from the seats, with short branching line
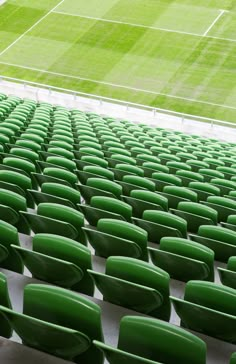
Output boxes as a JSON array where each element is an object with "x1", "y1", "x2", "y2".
[{"x1": 53, "y1": 10, "x2": 236, "y2": 42}]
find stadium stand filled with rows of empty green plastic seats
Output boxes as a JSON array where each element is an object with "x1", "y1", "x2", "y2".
[{"x1": 0, "y1": 94, "x2": 236, "y2": 364}]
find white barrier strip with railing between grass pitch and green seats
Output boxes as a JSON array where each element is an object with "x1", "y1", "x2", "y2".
[{"x1": 0, "y1": 75, "x2": 236, "y2": 142}]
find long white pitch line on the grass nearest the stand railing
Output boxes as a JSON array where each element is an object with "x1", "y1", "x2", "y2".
[{"x1": 0, "y1": 61, "x2": 236, "y2": 110}]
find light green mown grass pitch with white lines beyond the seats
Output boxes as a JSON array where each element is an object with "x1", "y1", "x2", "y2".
[{"x1": 0, "y1": 0, "x2": 236, "y2": 122}]
